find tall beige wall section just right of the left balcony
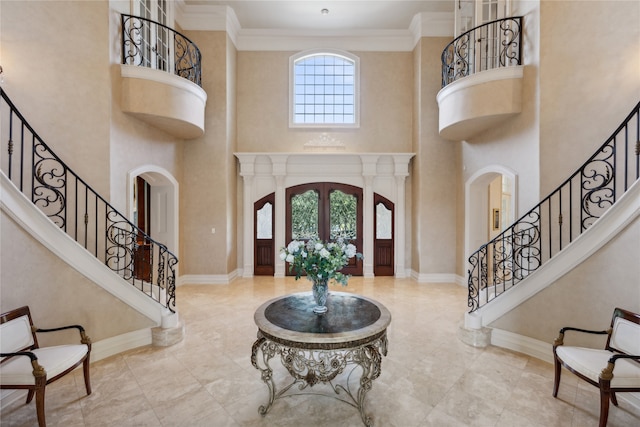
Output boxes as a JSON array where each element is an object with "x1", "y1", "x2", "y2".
[{"x1": 180, "y1": 31, "x2": 237, "y2": 275}]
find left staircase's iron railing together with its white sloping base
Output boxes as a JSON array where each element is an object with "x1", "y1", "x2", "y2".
[{"x1": 0, "y1": 88, "x2": 178, "y2": 350}]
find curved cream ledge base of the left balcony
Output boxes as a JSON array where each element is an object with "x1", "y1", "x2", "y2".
[{"x1": 120, "y1": 64, "x2": 207, "y2": 139}]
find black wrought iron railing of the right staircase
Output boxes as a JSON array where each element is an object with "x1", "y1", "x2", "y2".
[{"x1": 468, "y1": 103, "x2": 640, "y2": 313}]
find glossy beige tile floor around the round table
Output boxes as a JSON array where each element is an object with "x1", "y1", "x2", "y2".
[{"x1": 0, "y1": 278, "x2": 640, "y2": 427}]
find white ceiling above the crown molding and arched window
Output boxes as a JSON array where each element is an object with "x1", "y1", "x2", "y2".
[{"x1": 183, "y1": 0, "x2": 455, "y2": 32}]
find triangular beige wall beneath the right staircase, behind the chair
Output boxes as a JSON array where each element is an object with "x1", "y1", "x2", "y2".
[{"x1": 491, "y1": 220, "x2": 640, "y2": 345}]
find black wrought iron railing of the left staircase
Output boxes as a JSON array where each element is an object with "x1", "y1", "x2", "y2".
[{"x1": 0, "y1": 88, "x2": 178, "y2": 312}]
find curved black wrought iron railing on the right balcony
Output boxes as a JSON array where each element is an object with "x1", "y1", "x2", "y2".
[{"x1": 442, "y1": 16, "x2": 522, "y2": 87}]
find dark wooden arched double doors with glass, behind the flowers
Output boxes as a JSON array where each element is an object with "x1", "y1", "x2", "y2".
[{"x1": 285, "y1": 182, "x2": 363, "y2": 276}]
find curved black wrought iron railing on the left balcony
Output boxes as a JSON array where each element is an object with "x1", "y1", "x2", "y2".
[{"x1": 122, "y1": 14, "x2": 202, "y2": 86}]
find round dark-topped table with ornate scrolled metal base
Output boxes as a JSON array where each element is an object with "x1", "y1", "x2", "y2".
[{"x1": 251, "y1": 291, "x2": 391, "y2": 426}]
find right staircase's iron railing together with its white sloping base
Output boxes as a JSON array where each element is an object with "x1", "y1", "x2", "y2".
[{"x1": 465, "y1": 103, "x2": 640, "y2": 330}]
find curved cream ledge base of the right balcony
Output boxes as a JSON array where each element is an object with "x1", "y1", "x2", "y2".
[{"x1": 437, "y1": 66, "x2": 524, "y2": 141}]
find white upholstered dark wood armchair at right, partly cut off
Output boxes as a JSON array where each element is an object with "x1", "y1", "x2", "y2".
[{"x1": 553, "y1": 308, "x2": 640, "y2": 427}]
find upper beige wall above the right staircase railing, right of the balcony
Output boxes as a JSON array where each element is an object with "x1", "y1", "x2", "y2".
[{"x1": 539, "y1": 0, "x2": 640, "y2": 194}]
